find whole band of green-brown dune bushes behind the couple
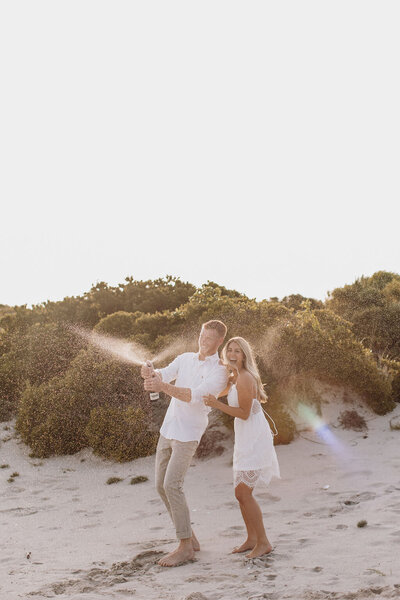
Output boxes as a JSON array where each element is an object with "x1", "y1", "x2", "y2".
[{"x1": 0, "y1": 271, "x2": 400, "y2": 461}]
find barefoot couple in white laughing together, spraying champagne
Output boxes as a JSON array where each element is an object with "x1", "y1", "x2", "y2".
[{"x1": 141, "y1": 320, "x2": 279, "y2": 567}]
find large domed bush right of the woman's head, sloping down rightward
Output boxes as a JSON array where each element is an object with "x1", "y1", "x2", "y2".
[{"x1": 263, "y1": 308, "x2": 394, "y2": 414}]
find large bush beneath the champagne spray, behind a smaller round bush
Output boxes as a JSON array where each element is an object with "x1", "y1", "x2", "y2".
[{"x1": 16, "y1": 348, "x2": 149, "y2": 458}]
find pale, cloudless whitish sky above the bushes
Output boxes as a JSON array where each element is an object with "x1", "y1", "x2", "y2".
[{"x1": 0, "y1": 0, "x2": 400, "y2": 305}]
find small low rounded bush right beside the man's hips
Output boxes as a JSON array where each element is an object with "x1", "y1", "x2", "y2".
[{"x1": 86, "y1": 406, "x2": 158, "y2": 462}]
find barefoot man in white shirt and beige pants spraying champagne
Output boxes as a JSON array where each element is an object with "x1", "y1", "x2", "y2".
[{"x1": 141, "y1": 320, "x2": 228, "y2": 567}]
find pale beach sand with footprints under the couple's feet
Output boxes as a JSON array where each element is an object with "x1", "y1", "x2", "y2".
[{"x1": 0, "y1": 394, "x2": 400, "y2": 600}]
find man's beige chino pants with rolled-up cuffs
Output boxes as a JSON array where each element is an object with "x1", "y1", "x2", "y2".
[{"x1": 156, "y1": 435, "x2": 198, "y2": 540}]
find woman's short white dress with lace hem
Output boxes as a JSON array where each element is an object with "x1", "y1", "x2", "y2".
[{"x1": 228, "y1": 385, "x2": 280, "y2": 488}]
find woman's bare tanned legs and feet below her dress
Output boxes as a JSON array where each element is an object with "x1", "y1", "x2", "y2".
[{"x1": 235, "y1": 483, "x2": 272, "y2": 558}]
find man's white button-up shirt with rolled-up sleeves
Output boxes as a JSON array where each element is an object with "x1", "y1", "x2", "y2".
[{"x1": 159, "y1": 352, "x2": 228, "y2": 442}]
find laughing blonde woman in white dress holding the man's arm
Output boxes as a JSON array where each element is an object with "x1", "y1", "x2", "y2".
[{"x1": 203, "y1": 337, "x2": 280, "y2": 558}]
